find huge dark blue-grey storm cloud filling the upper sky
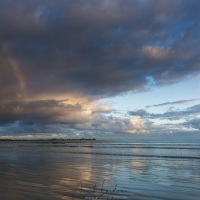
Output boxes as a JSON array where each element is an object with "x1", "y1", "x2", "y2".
[{"x1": 0, "y1": 0, "x2": 200, "y2": 98}]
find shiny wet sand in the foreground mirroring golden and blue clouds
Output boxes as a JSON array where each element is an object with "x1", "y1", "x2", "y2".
[{"x1": 0, "y1": 141, "x2": 200, "y2": 200}]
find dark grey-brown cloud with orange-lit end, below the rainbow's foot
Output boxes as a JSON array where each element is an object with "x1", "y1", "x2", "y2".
[{"x1": 0, "y1": 100, "x2": 84, "y2": 125}]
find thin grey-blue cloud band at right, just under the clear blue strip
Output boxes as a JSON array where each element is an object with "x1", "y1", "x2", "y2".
[{"x1": 128, "y1": 104, "x2": 200, "y2": 120}]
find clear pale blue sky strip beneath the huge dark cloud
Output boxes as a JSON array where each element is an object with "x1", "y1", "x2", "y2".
[{"x1": 101, "y1": 76, "x2": 200, "y2": 114}]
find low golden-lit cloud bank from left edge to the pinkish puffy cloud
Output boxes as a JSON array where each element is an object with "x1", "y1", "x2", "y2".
[{"x1": 0, "y1": 100, "x2": 148, "y2": 134}]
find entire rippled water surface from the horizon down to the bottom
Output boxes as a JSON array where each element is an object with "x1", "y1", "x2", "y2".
[{"x1": 0, "y1": 140, "x2": 200, "y2": 200}]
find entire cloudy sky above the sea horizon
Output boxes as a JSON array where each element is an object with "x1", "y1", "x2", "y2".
[{"x1": 0, "y1": 0, "x2": 200, "y2": 138}]
